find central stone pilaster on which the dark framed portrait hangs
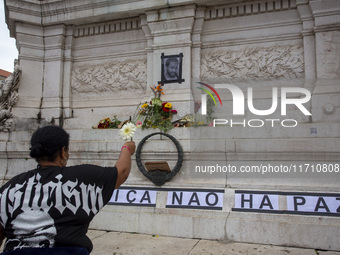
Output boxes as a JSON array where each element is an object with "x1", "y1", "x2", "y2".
[{"x1": 144, "y1": 5, "x2": 197, "y2": 116}]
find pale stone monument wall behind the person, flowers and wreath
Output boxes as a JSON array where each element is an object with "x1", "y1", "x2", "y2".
[{"x1": 0, "y1": 0, "x2": 340, "y2": 250}]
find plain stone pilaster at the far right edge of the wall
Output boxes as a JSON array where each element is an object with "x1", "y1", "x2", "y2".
[{"x1": 309, "y1": 0, "x2": 340, "y2": 122}]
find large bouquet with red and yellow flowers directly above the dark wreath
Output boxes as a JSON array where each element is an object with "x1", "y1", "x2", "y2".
[{"x1": 136, "y1": 84, "x2": 177, "y2": 133}]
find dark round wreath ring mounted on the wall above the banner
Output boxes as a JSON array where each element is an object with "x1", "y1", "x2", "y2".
[{"x1": 136, "y1": 132, "x2": 183, "y2": 182}]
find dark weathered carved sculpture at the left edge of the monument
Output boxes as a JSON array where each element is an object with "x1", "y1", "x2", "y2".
[{"x1": 0, "y1": 60, "x2": 22, "y2": 131}]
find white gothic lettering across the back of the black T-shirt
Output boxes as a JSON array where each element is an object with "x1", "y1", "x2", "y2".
[{"x1": 0, "y1": 173, "x2": 104, "y2": 222}]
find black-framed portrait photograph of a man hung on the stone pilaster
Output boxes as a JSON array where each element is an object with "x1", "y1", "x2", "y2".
[{"x1": 158, "y1": 53, "x2": 184, "y2": 85}]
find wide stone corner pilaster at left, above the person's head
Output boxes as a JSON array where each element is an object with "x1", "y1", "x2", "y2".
[{"x1": 13, "y1": 23, "x2": 68, "y2": 126}]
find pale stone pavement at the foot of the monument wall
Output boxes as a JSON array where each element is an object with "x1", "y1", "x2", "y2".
[{"x1": 88, "y1": 230, "x2": 330, "y2": 255}]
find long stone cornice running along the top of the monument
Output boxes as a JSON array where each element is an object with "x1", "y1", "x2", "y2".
[{"x1": 5, "y1": 0, "x2": 339, "y2": 37}]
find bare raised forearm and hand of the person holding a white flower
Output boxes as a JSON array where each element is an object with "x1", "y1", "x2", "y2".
[{"x1": 115, "y1": 142, "x2": 136, "y2": 189}]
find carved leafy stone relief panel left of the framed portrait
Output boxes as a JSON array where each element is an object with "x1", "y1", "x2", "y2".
[{"x1": 71, "y1": 58, "x2": 147, "y2": 94}]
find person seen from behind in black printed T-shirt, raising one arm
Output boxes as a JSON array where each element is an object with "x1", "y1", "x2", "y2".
[{"x1": 0, "y1": 126, "x2": 136, "y2": 255}]
